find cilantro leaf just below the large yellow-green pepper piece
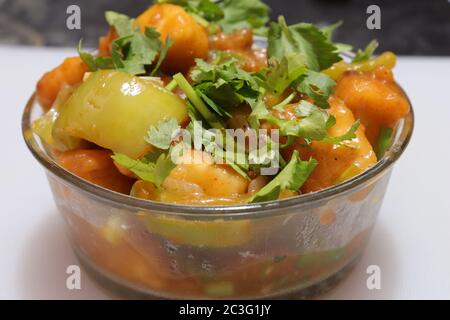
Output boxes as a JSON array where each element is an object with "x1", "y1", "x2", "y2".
[{"x1": 111, "y1": 153, "x2": 175, "y2": 189}]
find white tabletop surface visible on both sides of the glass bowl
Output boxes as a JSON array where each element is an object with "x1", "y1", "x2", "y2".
[{"x1": 0, "y1": 46, "x2": 450, "y2": 299}]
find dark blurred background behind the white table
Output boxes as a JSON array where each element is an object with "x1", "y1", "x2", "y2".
[{"x1": 0, "y1": 0, "x2": 450, "y2": 56}]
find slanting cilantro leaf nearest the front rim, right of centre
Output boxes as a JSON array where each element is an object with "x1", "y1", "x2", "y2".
[{"x1": 248, "y1": 150, "x2": 317, "y2": 203}]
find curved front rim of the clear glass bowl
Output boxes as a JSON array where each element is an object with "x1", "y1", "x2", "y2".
[{"x1": 22, "y1": 85, "x2": 414, "y2": 219}]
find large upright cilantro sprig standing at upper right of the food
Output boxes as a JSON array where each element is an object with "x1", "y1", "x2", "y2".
[{"x1": 260, "y1": 17, "x2": 341, "y2": 108}]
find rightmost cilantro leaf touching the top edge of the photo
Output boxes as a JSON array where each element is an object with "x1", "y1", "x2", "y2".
[{"x1": 218, "y1": 0, "x2": 269, "y2": 33}]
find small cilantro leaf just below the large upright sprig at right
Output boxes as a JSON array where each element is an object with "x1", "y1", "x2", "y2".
[{"x1": 297, "y1": 70, "x2": 336, "y2": 108}]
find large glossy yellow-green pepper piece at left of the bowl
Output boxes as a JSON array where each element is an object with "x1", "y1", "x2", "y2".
[{"x1": 53, "y1": 70, "x2": 187, "y2": 159}]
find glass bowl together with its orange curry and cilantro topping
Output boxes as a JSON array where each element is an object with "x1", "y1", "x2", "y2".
[{"x1": 24, "y1": 0, "x2": 412, "y2": 298}]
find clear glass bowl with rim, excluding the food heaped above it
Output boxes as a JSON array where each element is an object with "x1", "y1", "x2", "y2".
[{"x1": 22, "y1": 93, "x2": 414, "y2": 298}]
